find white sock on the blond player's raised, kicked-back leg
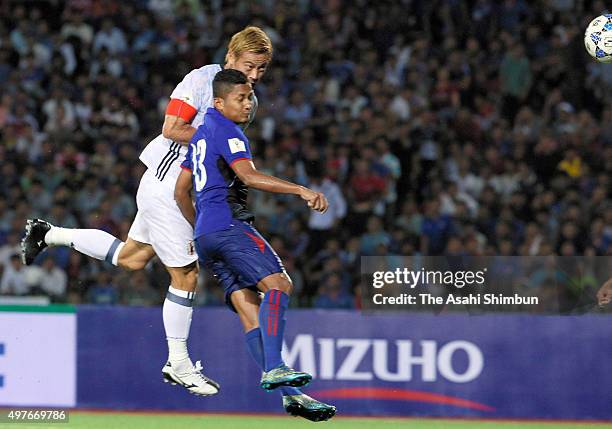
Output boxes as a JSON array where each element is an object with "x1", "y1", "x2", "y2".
[{"x1": 45, "y1": 226, "x2": 125, "y2": 265}]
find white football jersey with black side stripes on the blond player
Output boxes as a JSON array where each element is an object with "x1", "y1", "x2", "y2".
[{"x1": 140, "y1": 64, "x2": 257, "y2": 192}]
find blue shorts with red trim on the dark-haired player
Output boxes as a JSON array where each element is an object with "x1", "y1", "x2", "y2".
[{"x1": 196, "y1": 219, "x2": 285, "y2": 311}]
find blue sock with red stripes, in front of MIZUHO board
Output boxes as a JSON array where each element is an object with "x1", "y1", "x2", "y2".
[{"x1": 259, "y1": 289, "x2": 289, "y2": 371}]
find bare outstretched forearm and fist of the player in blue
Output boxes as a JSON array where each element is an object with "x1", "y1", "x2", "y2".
[{"x1": 231, "y1": 159, "x2": 329, "y2": 213}]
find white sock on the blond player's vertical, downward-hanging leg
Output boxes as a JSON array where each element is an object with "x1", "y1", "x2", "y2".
[{"x1": 163, "y1": 286, "x2": 195, "y2": 370}]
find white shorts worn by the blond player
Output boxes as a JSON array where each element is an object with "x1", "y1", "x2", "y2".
[{"x1": 128, "y1": 170, "x2": 198, "y2": 267}]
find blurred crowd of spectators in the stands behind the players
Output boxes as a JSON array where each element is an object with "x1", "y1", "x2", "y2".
[{"x1": 0, "y1": 0, "x2": 612, "y2": 308}]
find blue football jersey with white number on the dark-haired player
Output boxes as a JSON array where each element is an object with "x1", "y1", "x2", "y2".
[{"x1": 181, "y1": 107, "x2": 253, "y2": 238}]
